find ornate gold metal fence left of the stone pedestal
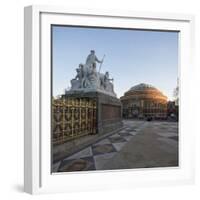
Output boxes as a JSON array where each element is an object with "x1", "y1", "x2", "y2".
[{"x1": 52, "y1": 98, "x2": 97, "y2": 144}]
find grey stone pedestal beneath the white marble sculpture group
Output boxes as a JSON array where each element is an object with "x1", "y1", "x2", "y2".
[{"x1": 63, "y1": 91, "x2": 123, "y2": 135}]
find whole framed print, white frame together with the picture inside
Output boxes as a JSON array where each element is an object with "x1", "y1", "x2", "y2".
[{"x1": 24, "y1": 6, "x2": 194, "y2": 194}]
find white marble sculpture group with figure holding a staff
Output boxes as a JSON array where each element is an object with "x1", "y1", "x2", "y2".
[{"x1": 70, "y1": 50, "x2": 116, "y2": 96}]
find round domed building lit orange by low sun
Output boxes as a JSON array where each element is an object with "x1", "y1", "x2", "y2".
[{"x1": 120, "y1": 83, "x2": 167, "y2": 119}]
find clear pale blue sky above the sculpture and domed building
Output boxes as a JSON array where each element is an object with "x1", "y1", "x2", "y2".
[{"x1": 52, "y1": 26, "x2": 178, "y2": 99}]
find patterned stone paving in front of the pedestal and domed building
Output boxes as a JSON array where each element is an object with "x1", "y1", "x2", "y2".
[{"x1": 53, "y1": 120, "x2": 178, "y2": 172}]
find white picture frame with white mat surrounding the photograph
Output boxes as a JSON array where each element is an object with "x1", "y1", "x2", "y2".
[{"x1": 24, "y1": 6, "x2": 194, "y2": 194}]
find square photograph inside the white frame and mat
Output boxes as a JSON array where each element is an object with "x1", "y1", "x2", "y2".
[{"x1": 50, "y1": 24, "x2": 180, "y2": 173}]
